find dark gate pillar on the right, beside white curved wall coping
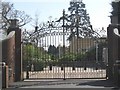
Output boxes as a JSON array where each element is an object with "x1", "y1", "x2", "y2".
[{"x1": 108, "y1": 24, "x2": 120, "y2": 86}]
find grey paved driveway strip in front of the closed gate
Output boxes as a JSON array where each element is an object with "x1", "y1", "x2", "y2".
[{"x1": 9, "y1": 79, "x2": 118, "y2": 90}]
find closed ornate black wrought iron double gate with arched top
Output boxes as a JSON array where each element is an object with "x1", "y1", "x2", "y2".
[{"x1": 22, "y1": 13, "x2": 107, "y2": 79}]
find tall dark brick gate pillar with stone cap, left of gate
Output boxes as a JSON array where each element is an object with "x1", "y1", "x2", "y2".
[{"x1": 7, "y1": 19, "x2": 22, "y2": 81}]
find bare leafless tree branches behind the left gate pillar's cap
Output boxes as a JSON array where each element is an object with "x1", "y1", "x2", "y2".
[{"x1": 2, "y1": 2, "x2": 32, "y2": 29}]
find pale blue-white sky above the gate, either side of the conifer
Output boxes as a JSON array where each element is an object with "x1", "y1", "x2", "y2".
[{"x1": 3, "y1": 0, "x2": 112, "y2": 29}]
